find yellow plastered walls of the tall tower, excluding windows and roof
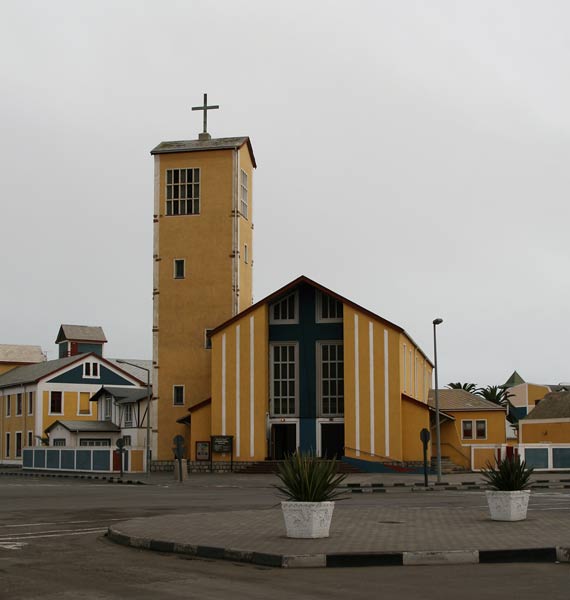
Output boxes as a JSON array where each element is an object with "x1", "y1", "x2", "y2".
[{"x1": 154, "y1": 150, "x2": 253, "y2": 459}]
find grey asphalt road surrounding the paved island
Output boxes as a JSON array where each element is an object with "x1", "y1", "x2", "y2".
[{"x1": 0, "y1": 475, "x2": 570, "y2": 600}]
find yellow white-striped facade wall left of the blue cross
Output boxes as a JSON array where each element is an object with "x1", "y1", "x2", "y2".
[{"x1": 211, "y1": 305, "x2": 269, "y2": 461}]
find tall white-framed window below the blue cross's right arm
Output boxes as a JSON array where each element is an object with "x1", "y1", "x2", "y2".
[{"x1": 318, "y1": 342, "x2": 344, "y2": 417}]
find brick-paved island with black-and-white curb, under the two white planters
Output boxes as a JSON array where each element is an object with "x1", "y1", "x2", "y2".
[{"x1": 108, "y1": 498, "x2": 570, "y2": 568}]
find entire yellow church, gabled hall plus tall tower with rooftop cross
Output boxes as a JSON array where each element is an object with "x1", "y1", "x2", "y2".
[{"x1": 151, "y1": 95, "x2": 433, "y2": 463}]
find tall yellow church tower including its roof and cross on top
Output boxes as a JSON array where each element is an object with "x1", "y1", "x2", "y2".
[{"x1": 151, "y1": 94, "x2": 256, "y2": 460}]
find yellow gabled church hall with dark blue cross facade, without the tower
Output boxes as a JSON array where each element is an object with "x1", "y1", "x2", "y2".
[{"x1": 182, "y1": 277, "x2": 432, "y2": 469}]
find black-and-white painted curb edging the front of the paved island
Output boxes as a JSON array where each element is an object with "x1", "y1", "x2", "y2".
[{"x1": 106, "y1": 527, "x2": 570, "y2": 569}]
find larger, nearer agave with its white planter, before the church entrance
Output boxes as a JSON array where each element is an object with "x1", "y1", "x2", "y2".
[{"x1": 275, "y1": 451, "x2": 346, "y2": 538}]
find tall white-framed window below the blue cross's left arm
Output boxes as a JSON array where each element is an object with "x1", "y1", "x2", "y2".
[{"x1": 270, "y1": 343, "x2": 298, "y2": 416}]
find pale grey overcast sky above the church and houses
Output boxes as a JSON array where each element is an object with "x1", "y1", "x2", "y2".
[{"x1": 0, "y1": 0, "x2": 570, "y2": 385}]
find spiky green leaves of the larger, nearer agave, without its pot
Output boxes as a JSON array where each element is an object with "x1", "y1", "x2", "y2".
[{"x1": 275, "y1": 452, "x2": 346, "y2": 502}]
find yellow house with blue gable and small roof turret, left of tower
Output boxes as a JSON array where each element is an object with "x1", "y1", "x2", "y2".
[{"x1": 0, "y1": 325, "x2": 151, "y2": 470}]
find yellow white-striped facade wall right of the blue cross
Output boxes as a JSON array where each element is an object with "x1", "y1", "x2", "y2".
[{"x1": 343, "y1": 304, "x2": 403, "y2": 461}]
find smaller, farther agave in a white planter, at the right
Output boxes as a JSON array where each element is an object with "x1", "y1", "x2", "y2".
[{"x1": 482, "y1": 456, "x2": 534, "y2": 521}]
